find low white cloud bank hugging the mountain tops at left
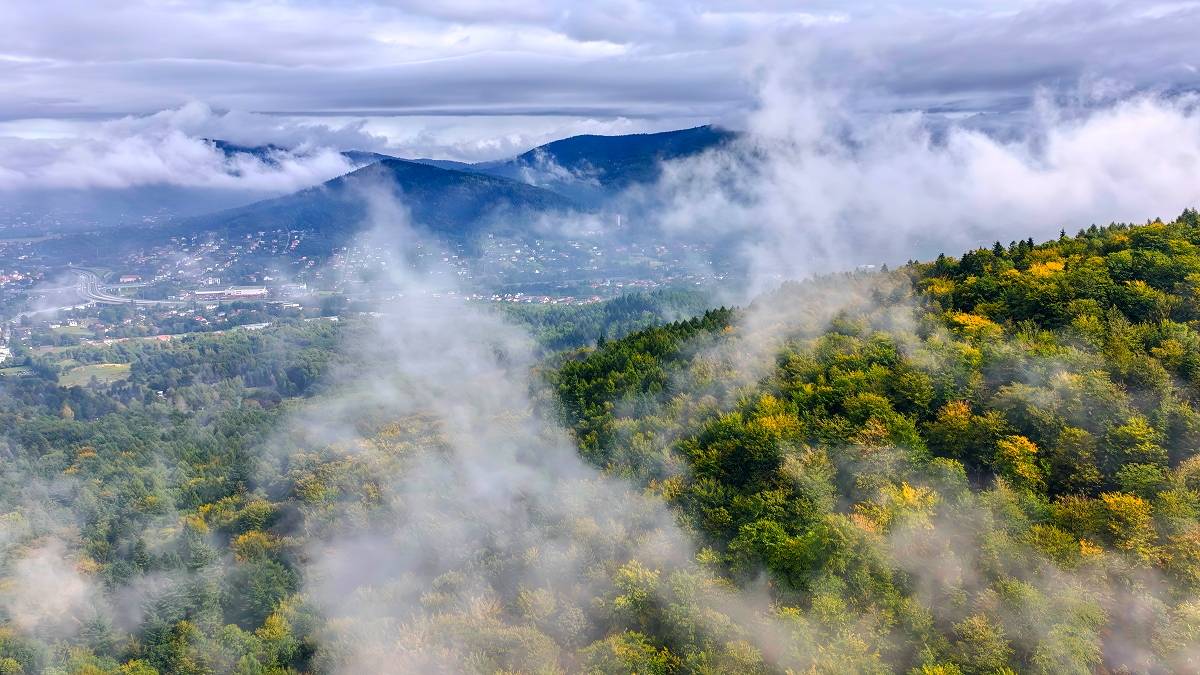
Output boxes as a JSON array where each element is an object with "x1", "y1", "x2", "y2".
[{"x1": 0, "y1": 102, "x2": 706, "y2": 193}]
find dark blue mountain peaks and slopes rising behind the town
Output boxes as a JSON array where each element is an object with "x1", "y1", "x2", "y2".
[{"x1": 182, "y1": 126, "x2": 734, "y2": 240}]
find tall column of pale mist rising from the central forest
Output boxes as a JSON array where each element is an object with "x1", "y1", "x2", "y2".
[{"x1": 260, "y1": 186, "x2": 811, "y2": 673}]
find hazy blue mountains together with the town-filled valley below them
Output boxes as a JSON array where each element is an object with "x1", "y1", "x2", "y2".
[{"x1": 0, "y1": 127, "x2": 733, "y2": 357}]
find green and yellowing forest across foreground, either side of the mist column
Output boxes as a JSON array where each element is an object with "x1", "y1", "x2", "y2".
[{"x1": 0, "y1": 210, "x2": 1200, "y2": 674}]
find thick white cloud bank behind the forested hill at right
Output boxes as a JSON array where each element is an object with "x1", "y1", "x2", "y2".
[{"x1": 629, "y1": 71, "x2": 1200, "y2": 291}]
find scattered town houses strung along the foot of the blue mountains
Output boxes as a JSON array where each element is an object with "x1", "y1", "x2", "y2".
[{"x1": 0, "y1": 212, "x2": 724, "y2": 333}]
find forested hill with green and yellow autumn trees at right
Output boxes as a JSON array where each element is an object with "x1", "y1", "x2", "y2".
[{"x1": 554, "y1": 210, "x2": 1200, "y2": 673}]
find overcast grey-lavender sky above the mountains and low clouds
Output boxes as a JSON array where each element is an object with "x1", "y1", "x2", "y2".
[{"x1": 0, "y1": 0, "x2": 1200, "y2": 160}]
